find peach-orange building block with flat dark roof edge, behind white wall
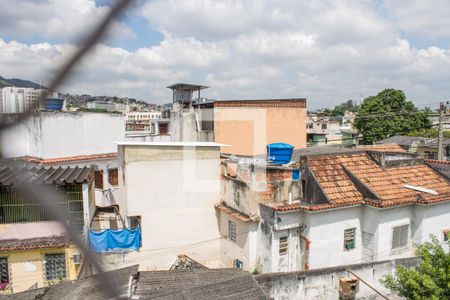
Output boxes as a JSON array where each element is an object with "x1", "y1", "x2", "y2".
[{"x1": 193, "y1": 98, "x2": 307, "y2": 156}]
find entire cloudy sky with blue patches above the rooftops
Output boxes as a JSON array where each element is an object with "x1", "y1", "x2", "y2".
[{"x1": 0, "y1": 0, "x2": 450, "y2": 109}]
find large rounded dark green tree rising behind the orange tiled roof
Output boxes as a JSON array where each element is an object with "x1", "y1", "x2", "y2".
[{"x1": 354, "y1": 89, "x2": 431, "y2": 144}]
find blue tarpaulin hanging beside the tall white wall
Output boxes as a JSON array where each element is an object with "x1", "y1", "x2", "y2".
[{"x1": 89, "y1": 228, "x2": 141, "y2": 253}]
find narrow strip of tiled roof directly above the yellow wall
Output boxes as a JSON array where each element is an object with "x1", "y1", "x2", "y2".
[{"x1": 0, "y1": 236, "x2": 69, "y2": 251}]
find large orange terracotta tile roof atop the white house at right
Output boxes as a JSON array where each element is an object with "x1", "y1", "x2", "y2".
[{"x1": 308, "y1": 153, "x2": 450, "y2": 207}]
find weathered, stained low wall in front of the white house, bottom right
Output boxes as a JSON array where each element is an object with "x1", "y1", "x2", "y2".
[{"x1": 255, "y1": 259, "x2": 417, "y2": 300}]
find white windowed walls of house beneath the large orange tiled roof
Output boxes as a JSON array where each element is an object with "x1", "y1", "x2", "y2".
[{"x1": 264, "y1": 202, "x2": 450, "y2": 272}]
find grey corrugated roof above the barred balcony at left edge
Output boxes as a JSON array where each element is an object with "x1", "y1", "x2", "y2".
[{"x1": 0, "y1": 165, "x2": 93, "y2": 185}]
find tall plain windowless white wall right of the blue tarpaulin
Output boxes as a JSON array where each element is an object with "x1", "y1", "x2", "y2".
[{"x1": 119, "y1": 142, "x2": 225, "y2": 270}]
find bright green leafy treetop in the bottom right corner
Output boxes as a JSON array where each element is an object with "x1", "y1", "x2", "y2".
[{"x1": 380, "y1": 236, "x2": 450, "y2": 300}]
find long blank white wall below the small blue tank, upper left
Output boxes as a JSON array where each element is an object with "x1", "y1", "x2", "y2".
[{"x1": 0, "y1": 112, "x2": 125, "y2": 159}]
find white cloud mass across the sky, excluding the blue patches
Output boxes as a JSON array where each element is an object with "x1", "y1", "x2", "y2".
[{"x1": 0, "y1": 0, "x2": 450, "y2": 108}]
